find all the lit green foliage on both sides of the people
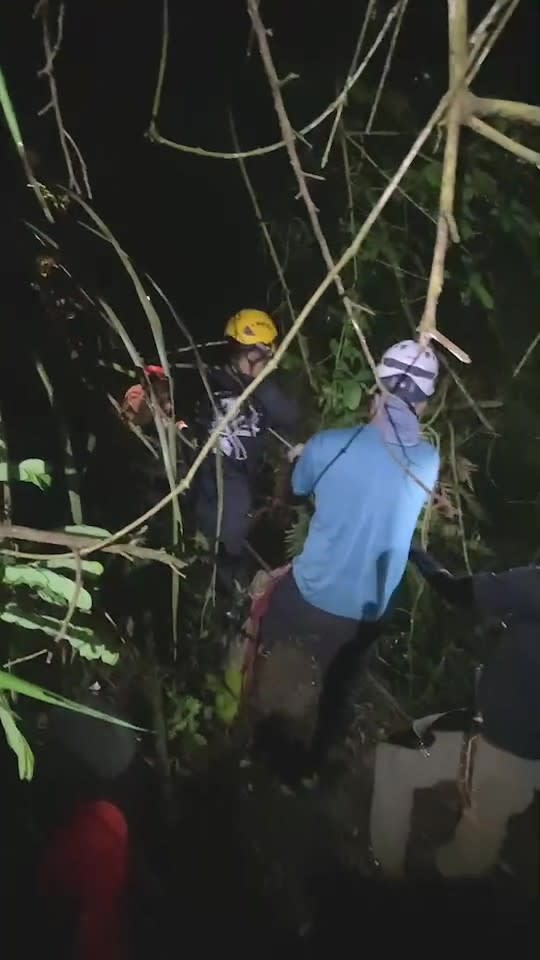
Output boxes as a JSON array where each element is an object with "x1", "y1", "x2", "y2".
[{"x1": 0, "y1": 5, "x2": 540, "y2": 777}]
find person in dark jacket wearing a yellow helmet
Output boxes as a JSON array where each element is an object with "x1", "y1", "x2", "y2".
[{"x1": 195, "y1": 310, "x2": 298, "y2": 593}]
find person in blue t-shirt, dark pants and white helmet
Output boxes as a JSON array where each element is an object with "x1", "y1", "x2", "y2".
[{"x1": 251, "y1": 340, "x2": 439, "y2": 784}]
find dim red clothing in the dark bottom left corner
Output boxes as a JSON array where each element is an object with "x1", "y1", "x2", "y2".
[{"x1": 39, "y1": 800, "x2": 128, "y2": 960}]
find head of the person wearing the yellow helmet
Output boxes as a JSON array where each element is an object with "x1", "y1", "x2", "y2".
[{"x1": 225, "y1": 310, "x2": 278, "y2": 378}]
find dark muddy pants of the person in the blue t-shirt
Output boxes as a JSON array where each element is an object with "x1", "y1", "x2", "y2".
[{"x1": 253, "y1": 572, "x2": 379, "y2": 779}]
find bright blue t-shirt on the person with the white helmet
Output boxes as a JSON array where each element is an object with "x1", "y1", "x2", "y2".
[{"x1": 292, "y1": 424, "x2": 439, "y2": 620}]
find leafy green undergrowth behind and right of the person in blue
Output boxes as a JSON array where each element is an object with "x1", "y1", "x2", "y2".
[{"x1": 272, "y1": 85, "x2": 540, "y2": 710}]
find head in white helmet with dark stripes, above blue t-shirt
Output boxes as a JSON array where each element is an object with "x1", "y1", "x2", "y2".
[{"x1": 377, "y1": 340, "x2": 439, "y2": 416}]
